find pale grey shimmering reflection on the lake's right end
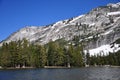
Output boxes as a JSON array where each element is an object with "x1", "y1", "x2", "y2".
[{"x1": 89, "y1": 68, "x2": 120, "y2": 80}]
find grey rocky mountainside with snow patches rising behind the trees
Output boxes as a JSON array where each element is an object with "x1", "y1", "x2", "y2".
[{"x1": 1, "y1": 2, "x2": 120, "y2": 54}]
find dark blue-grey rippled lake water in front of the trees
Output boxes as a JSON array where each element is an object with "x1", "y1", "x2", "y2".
[{"x1": 0, "y1": 67, "x2": 120, "y2": 80}]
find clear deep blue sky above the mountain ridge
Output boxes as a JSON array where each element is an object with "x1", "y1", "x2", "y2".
[{"x1": 0, "y1": 0, "x2": 119, "y2": 41}]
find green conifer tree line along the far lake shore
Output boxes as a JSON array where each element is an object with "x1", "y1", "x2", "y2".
[{"x1": 0, "y1": 39, "x2": 120, "y2": 69}]
